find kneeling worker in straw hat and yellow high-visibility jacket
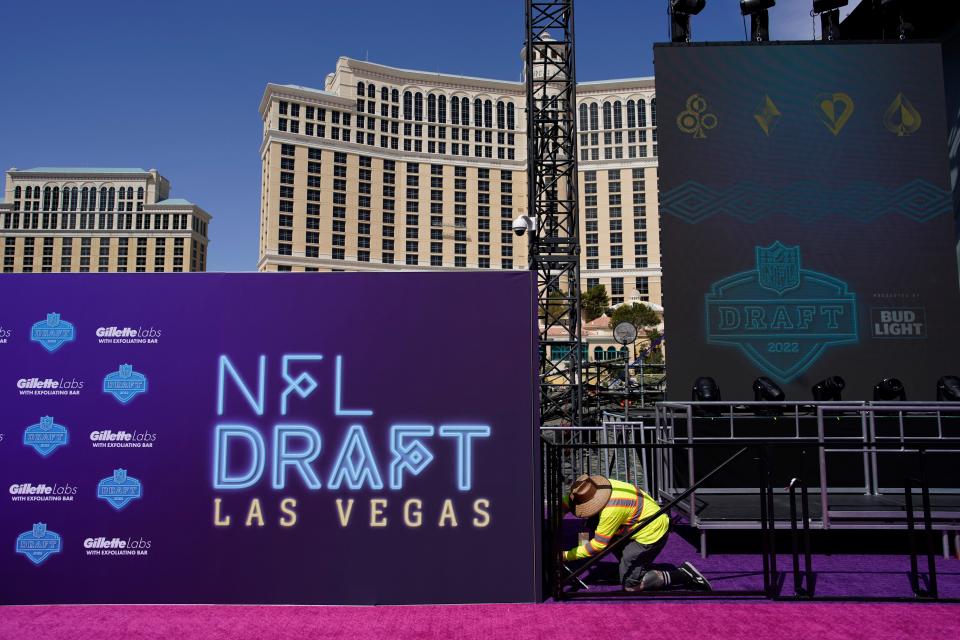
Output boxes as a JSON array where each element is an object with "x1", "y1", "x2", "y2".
[{"x1": 563, "y1": 475, "x2": 710, "y2": 591}]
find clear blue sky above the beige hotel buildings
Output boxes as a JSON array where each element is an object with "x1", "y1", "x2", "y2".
[{"x1": 0, "y1": 0, "x2": 856, "y2": 271}]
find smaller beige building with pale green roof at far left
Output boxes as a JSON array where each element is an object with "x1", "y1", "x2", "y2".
[{"x1": 0, "y1": 167, "x2": 210, "y2": 273}]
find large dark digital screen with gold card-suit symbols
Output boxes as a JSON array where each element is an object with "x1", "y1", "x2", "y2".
[{"x1": 655, "y1": 42, "x2": 960, "y2": 400}]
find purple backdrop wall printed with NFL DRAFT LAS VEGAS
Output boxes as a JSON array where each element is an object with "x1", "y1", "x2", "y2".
[{"x1": 0, "y1": 273, "x2": 539, "y2": 604}]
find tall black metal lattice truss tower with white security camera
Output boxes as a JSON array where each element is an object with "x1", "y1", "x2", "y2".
[{"x1": 525, "y1": 0, "x2": 582, "y2": 425}]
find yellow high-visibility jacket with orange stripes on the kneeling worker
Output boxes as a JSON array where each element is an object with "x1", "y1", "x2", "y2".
[{"x1": 564, "y1": 480, "x2": 670, "y2": 561}]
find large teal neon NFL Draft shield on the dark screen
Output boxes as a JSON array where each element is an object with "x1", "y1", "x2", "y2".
[{"x1": 705, "y1": 241, "x2": 858, "y2": 382}]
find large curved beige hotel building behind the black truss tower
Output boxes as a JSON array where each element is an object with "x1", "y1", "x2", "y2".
[{"x1": 258, "y1": 53, "x2": 661, "y2": 304}]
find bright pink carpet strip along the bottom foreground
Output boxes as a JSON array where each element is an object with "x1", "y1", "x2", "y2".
[{"x1": 0, "y1": 603, "x2": 960, "y2": 640}]
